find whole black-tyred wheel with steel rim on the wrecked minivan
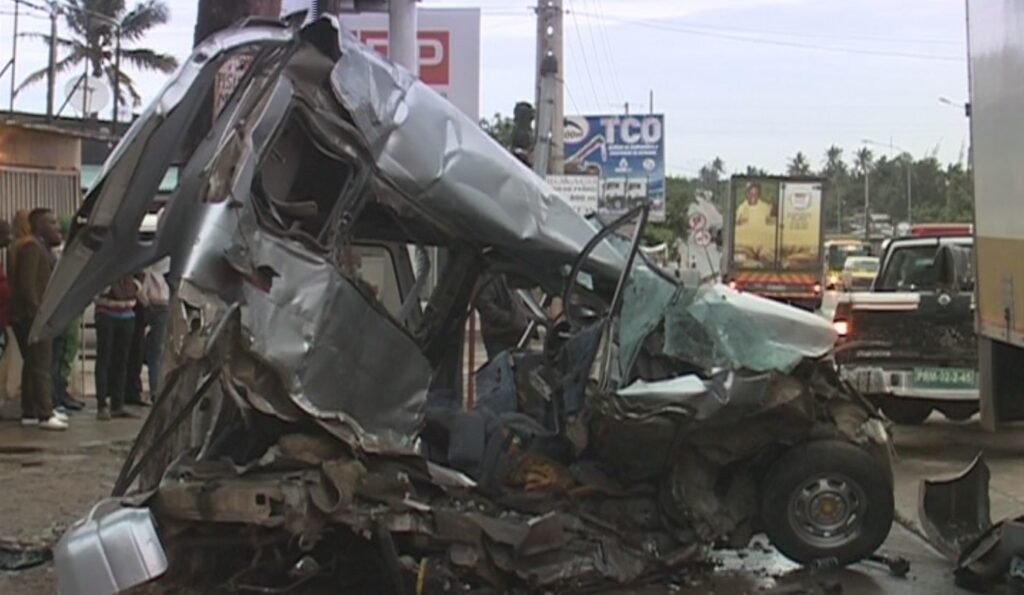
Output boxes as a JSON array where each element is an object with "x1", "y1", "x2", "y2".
[{"x1": 761, "y1": 440, "x2": 893, "y2": 566}]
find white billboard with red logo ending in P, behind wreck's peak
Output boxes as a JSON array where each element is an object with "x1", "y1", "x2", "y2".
[{"x1": 339, "y1": 8, "x2": 480, "y2": 122}]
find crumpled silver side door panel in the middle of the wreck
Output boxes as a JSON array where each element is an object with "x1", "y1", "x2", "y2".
[{"x1": 234, "y1": 228, "x2": 430, "y2": 449}]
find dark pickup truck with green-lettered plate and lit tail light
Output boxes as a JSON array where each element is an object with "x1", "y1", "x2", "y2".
[{"x1": 834, "y1": 236, "x2": 979, "y2": 424}]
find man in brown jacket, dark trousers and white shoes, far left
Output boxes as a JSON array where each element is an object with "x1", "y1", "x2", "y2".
[{"x1": 11, "y1": 209, "x2": 68, "y2": 430}]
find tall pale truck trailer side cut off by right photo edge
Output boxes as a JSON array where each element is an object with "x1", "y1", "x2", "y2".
[{"x1": 968, "y1": 0, "x2": 1024, "y2": 429}]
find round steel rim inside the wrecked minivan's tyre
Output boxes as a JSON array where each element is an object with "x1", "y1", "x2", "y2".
[{"x1": 788, "y1": 475, "x2": 866, "y2": 549}]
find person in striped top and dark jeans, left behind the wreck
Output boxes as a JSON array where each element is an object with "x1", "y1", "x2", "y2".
[{"x1": 95, "y1": 275, "x2": 140, "y2": 421}]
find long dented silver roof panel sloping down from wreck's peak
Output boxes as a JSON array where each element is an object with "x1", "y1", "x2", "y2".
[{"x1": 332, "y1": 19, "x2": 624, "y2": 279}]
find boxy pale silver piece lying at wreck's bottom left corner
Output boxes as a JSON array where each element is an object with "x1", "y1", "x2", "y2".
[{"x1": 53, "y1": 501, "x2": 167, "y2": 595}]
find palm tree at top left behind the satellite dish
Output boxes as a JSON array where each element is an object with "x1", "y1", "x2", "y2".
[{"x1": 18, "y1": 0, "x2": 178, "y2": 111}]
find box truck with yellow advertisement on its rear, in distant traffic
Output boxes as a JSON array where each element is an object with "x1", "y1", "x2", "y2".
[{"x1": 725, "y1": 175, "x2": 825, "y2": 310}]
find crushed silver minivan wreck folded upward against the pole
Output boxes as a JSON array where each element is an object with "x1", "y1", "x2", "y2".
[{"x1": 34, "y1": 17, "x2": 893, "y2": 594}]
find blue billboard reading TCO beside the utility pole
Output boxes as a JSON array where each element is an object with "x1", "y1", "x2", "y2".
[{"x1": 565, "y1": 115, "x2": 666, "y2": 221}]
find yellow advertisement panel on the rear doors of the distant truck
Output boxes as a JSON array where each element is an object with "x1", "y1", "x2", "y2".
[{"x1": 732, "y1": 177, "x2": 822, "y2": 270}]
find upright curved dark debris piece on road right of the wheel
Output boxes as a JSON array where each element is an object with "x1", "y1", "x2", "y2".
[{"x1": 919, "y1": 454, "x2": 992, "y2": 560}]
